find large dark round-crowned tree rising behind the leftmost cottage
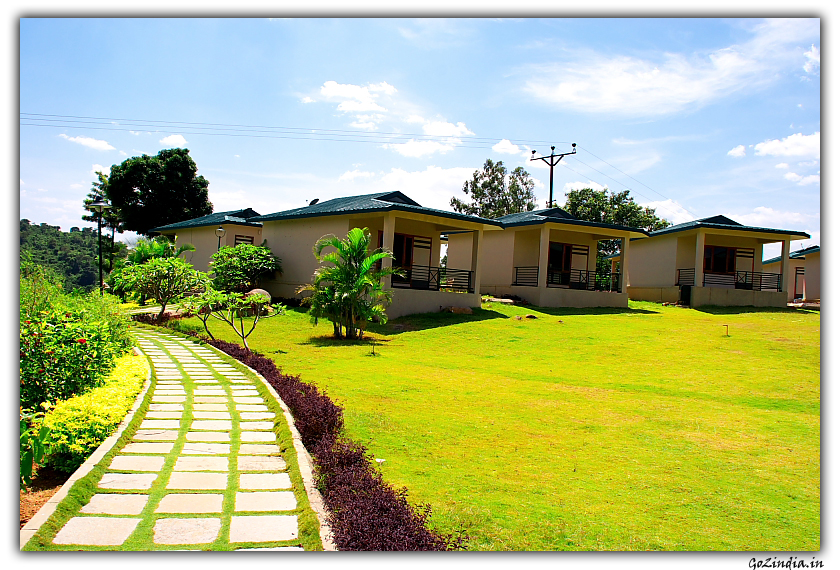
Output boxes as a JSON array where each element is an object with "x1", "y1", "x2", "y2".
[{"x1": 105, "y1": 148, "x2": 213, "y2": 234}]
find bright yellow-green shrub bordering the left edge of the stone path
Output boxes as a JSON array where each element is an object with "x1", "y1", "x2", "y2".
[{"x1": 43, "y1": 354, "x2": 148, "y2": 473}]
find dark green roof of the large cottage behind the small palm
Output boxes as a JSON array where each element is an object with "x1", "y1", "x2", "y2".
[{"x1": 254, "y1": 191, "x2": 501, "y2": 226}]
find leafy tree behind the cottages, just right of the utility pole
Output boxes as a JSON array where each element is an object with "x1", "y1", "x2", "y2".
[{"x1": 563, "y1": 184, "x2": 671, "y2": 270}]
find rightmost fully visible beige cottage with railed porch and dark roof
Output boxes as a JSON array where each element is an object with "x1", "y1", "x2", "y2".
[{"x1": 627, "y1": 216, "x2": 810, "y2": 307}]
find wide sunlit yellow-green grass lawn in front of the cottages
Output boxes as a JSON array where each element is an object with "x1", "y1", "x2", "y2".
[{"x1": 179, "y1": 302, "x2": 820, "y2": 551}]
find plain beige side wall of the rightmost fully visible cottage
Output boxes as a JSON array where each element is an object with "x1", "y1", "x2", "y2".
[{"x1": 626, "y1": 235, "x2": 680, "y2": 288}]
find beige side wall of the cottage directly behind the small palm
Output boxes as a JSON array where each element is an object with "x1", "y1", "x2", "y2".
[{"x1": 262, "y1": 216, "x2": 350, "y2": 299}]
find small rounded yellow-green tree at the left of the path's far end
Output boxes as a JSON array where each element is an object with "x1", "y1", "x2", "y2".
[{"x1": 115, "y1": 257, "x2": 207, "y2": 320}]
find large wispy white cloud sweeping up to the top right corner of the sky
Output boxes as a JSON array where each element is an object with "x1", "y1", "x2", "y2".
[{"x1": 522, "y1": 19, "x2": 819, "y2": 116}]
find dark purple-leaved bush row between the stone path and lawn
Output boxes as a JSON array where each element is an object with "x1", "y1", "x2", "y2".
[{"x1": 208, "y1": 340, "x2": 463, "y2": 551}]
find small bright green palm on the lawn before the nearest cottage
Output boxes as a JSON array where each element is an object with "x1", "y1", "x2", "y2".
[{"x1": 298, "y1": 228, "x2": 400, "y2": 339}]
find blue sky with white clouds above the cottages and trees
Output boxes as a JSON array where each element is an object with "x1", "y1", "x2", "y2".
[{"x1": 20, "y1": 18, "x2": 820, "y2": 257}]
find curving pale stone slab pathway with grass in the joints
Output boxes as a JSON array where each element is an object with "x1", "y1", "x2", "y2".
[{"x1": 35, "y1": 330, "x2": 316, "y2": 550}]
